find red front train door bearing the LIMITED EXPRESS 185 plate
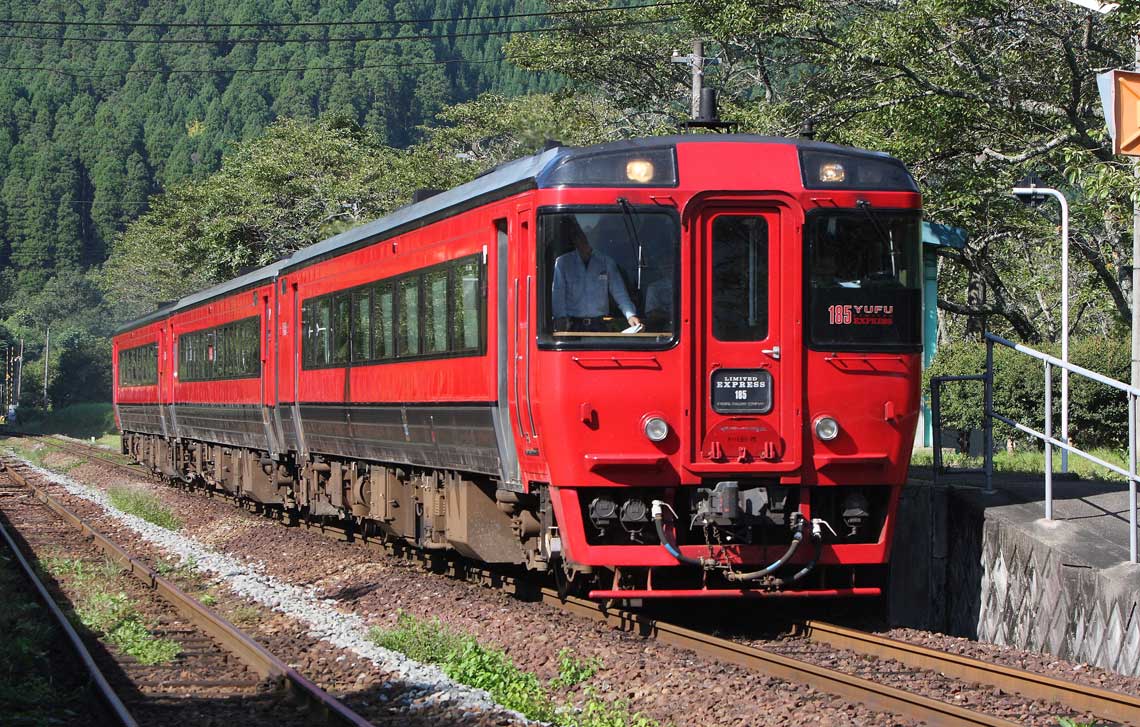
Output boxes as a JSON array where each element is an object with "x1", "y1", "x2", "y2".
[{"x1": 692, "y1": 202, "x2": 801, "y2": 473}]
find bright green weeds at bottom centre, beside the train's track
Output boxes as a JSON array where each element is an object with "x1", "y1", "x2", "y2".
[{"x1": 368, "y1": 613, "x2": 658, "y2": 727}]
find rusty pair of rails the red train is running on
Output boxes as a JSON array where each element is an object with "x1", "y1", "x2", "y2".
[{"x1": 22, "y1": 439, "x2": 1140, "y2": 727}]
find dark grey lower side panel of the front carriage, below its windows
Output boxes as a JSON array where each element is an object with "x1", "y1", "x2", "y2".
[{"x1": 298, "y1": 405, "x2": 500, "y2": 475}]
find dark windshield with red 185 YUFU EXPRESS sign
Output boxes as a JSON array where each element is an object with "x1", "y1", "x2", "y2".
[{"x1": 805, "y1": 206, "x2": 922, "y2": 351}]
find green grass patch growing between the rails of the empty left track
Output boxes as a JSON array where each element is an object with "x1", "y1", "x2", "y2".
[{"x1": 43, "y1": 556, "x2": 181, "y2": 664}]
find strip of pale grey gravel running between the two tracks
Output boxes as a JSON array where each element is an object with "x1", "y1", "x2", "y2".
[{"x1": 5, "y1": 458, "x2": 527, "y2": 722}]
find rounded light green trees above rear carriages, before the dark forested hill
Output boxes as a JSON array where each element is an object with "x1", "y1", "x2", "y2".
[{"x1": 104, "y1": 95, "x2": 622, "y2": 313}]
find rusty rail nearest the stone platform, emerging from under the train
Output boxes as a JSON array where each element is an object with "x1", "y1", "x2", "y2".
[{"x1": 804, "y1": 621, "x2": 1140, "y2": 725}]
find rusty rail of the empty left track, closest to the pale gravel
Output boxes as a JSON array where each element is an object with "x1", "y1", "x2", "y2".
[{"x1": 0, "y1": 458, "x2": 372, "y2": 727}]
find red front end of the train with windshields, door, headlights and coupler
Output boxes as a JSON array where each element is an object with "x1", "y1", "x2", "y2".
[{"x1": 526, "y1": 136, "x2": 922, "y2": 599}]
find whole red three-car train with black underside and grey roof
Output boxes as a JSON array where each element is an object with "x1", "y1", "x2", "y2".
[{"x1": 114, "y1": 134, "x2": 922, "y2": 599}]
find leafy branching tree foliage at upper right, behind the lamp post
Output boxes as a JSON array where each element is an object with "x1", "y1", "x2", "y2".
[{"x1": 510, "y1": 0, "x2": 1137, "y2": 341}]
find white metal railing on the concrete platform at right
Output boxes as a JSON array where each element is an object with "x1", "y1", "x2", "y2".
[{"x1": 930, "y1": 333, "x2": 1140, "y2": 563}]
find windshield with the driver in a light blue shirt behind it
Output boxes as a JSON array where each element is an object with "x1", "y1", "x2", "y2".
[{"x1": 538, "y1": 204, "x2": 681, "y2": 349}]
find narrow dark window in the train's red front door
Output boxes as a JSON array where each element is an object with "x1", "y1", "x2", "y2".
[{"x1": 710, "y1": 214, "x2": 768, "y2": 341}]
